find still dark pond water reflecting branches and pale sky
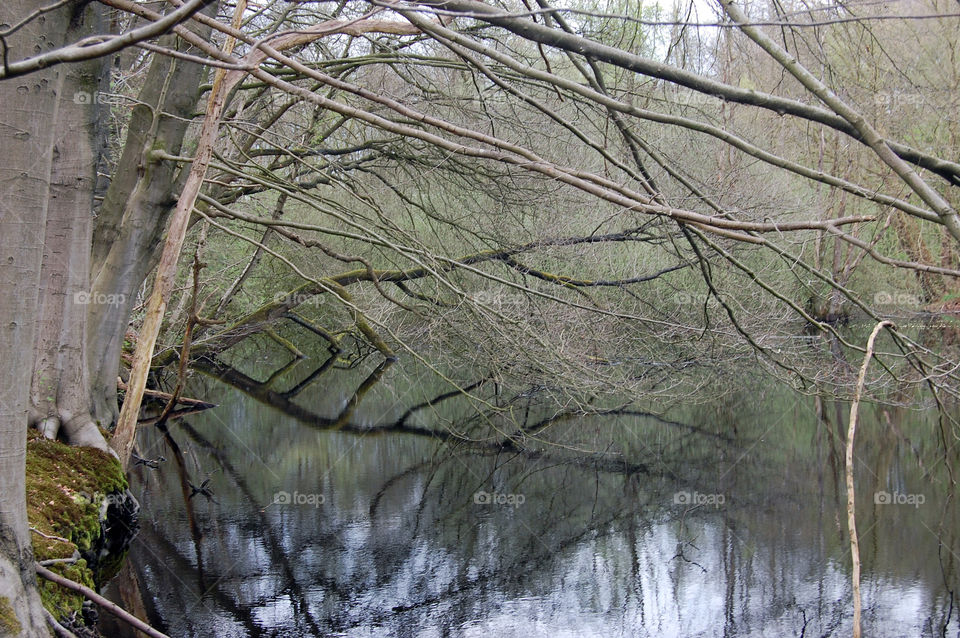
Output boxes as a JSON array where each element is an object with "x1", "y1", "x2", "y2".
[{"x1": 120, "y1": 352, "x2": 960, "y2": 638}]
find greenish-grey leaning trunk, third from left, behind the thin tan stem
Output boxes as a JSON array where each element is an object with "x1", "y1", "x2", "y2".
[{"x1": 87, "y1": 8, "x2": 218, "y2": 427}]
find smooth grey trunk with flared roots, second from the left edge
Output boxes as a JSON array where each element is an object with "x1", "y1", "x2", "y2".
[{"x1": 30, "y1": 4, "x2": 110, "y2": 451}]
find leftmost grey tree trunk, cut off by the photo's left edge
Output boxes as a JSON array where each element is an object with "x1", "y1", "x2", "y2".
[{"x1": 0, "y1": 0, "x2": 69, "y2": 637}]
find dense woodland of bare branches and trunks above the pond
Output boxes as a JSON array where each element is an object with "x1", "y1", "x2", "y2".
[{"x1": 0, "y1": 0, "x2": 960, "y2": 636}]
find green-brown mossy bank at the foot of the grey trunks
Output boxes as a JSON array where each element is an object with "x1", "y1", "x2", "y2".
[{"x1": 27, "y1": 431, "x2": 127, "y2": 618}]
